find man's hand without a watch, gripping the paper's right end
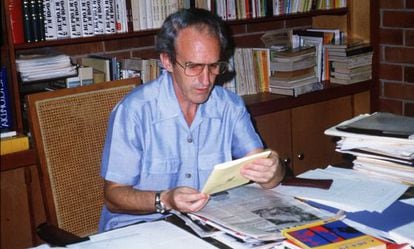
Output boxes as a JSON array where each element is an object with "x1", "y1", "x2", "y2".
[{"x1": 240, "y1": 150, "x2": 285, "y2": 188}]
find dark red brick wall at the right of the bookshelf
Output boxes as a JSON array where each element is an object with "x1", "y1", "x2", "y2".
[{"x1": 378, "y1": 0, "x2": 414, "y2": 117}]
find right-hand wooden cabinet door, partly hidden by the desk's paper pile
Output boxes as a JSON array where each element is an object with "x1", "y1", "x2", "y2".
[{"x1": 292, "y1": 96, "x2": 353, "y2": 175}]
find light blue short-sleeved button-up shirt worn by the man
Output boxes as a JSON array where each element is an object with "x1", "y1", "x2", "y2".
[{"x1": 99, "y1": 71, "x2": 263, "y2": 231}]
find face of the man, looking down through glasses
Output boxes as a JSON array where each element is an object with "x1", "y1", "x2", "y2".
[{"x1": 171, "y1": 27, "x2": 220, "y2": 105}]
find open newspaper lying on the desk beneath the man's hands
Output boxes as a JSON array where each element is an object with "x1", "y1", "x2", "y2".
[{"x1": 189, "y1": 184, "x2": 332, "y2": 241}]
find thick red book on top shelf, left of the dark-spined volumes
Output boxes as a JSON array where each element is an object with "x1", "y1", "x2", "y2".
[{"x1": 8, "y1": 0, "x2": 24, "y2": 44}]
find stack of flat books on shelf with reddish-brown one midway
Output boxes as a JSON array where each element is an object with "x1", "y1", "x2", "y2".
[{"x1": 269, "y1": 46, "x2": 322, "y2": 97}]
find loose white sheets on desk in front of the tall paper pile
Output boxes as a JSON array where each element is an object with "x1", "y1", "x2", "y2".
[{"x1": 275, "y1": 166, "x2": 409, "y2": 212}]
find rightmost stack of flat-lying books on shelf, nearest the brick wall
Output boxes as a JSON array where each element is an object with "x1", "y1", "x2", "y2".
[{"x1": 325, "y1": 40, "x2": 372, "y2": 84}]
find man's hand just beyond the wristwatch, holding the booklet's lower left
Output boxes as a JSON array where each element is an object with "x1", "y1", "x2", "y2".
[{"x1": 161, "y1": 187, "x2": 209, "y2": 213}]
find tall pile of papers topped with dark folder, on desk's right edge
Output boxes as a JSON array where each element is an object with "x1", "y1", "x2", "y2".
[{"x1": 325, "y1": 112, "x2": 414, "y2": 185}]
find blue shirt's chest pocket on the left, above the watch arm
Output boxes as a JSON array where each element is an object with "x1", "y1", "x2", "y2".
[{"x1": 139, "y1": 158, "x2": 181, "y2": 190}]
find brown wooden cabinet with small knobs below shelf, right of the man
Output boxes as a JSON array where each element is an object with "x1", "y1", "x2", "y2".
[{"x1": 254, "y1": 91, "x2": 370, "y2": 175}]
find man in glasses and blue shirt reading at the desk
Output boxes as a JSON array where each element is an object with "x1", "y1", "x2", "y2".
[{"x1": 100, "y1": 9, "x2": 284, "y2": 231}]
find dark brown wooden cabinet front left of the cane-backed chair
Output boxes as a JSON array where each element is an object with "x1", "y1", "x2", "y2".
[{"x1": 0, "y1": 165, "x2": 45, "y2": 249}]
